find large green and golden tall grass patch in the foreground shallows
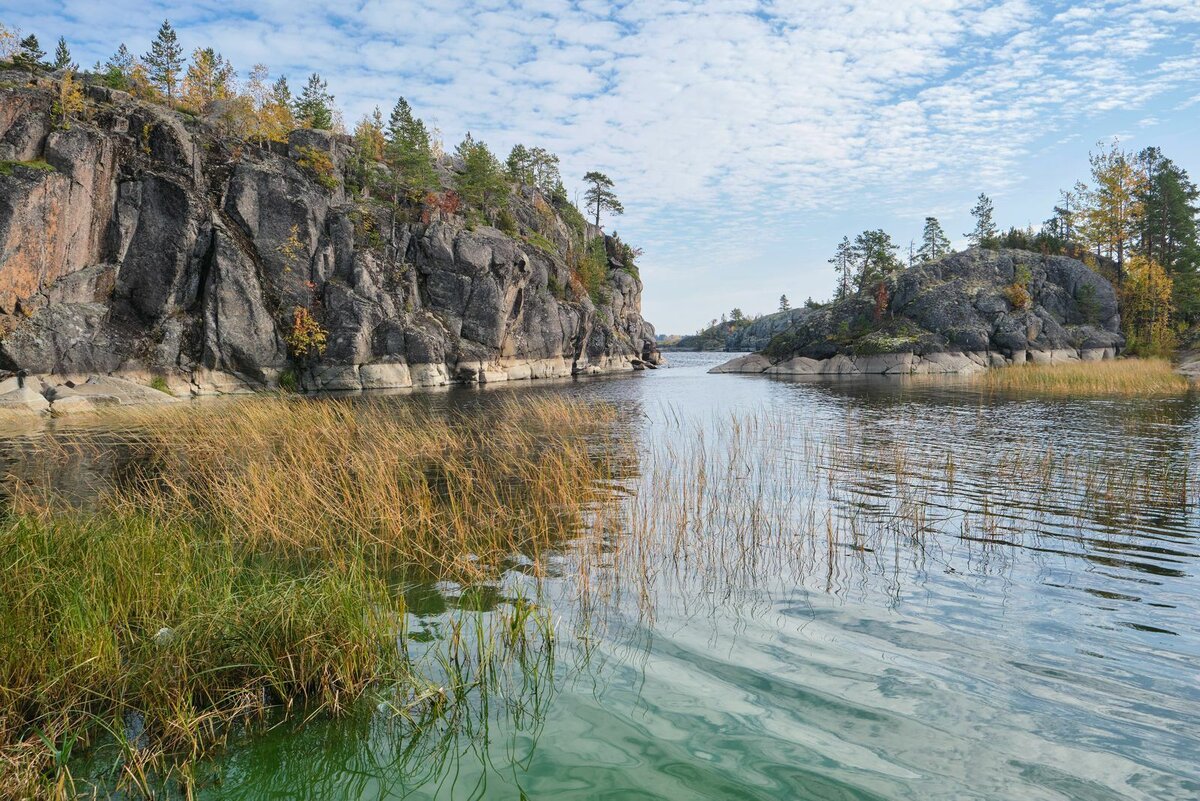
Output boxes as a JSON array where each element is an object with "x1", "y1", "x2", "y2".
[{"x1": 0, "y1": 398, "x2": 611, "y2": 797}]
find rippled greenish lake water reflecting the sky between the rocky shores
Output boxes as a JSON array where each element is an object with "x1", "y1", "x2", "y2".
[{"x1": 9, "y1": 354, "x2": 1200, "y2": 801}]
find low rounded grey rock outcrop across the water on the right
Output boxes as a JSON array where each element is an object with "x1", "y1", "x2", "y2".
[{"x1": 713, "y1": 249, "x2": 1124, "y2": 375}]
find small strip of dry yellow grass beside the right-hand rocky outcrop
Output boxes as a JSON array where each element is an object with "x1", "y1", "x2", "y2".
[{"x1": 974, "y1": 359, "x2": 1190, "y2": 397}]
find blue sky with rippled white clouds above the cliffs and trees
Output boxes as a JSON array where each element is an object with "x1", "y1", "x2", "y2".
[{"x1": 7, "y1": 0, "x2": 1200, "y2": 333}]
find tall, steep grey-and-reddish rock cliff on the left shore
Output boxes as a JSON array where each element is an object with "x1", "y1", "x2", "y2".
[{"x1": 0, "y1": 79, "x2": 659, "y2": 395}]
